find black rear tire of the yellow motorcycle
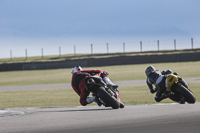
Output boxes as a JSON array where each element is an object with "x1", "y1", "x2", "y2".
[{"x1": 175, "y1": 85, "x2": 196, "y2": 103}]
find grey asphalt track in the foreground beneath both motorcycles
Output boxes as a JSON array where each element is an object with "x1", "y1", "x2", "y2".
[{"x1": 0, "y1": 103, "x2": 200, "y2": 133}]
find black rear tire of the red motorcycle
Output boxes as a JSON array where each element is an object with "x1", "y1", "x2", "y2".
[{"x1": 97, "y1": 87, "x2": 120, "y2": 109}]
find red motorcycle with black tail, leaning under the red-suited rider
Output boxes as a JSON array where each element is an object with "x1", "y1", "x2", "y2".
[{"x1": 85, "y1": 76, "x2": 124, "y2": 109}]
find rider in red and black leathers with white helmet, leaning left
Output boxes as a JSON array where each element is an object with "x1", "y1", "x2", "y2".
[{"x1": 71, "y1": 66, "x2": 118, "y2": 106}]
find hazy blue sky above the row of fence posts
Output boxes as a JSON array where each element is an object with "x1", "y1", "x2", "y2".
[{"x1": 0, "y1": 0, "x2": 200, "y2": 58}]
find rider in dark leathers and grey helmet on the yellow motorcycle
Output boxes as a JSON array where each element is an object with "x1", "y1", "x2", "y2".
[{"x1": 145, "y1": 66, "x2": 188, "y2": 103}]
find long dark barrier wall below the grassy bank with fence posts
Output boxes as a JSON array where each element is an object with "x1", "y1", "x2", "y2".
[{"x1": 0, "y1": 51, "x2": 200, "y2": 71}]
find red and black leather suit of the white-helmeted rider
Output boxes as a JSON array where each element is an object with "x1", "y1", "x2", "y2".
[{"x1": 71, "y1": 69, "x2": 108, "y2": 106}]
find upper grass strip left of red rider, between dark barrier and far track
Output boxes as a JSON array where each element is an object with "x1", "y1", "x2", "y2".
[{"x1": 0, "y1": 69, "x2": 71, "y2": 86}]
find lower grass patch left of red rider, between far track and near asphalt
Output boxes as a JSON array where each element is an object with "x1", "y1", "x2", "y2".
[{"x1": 0, "y1": 89, "x2": 79, "y2": 108}]
